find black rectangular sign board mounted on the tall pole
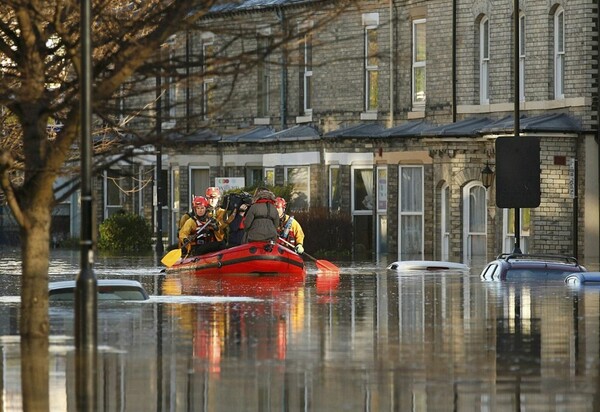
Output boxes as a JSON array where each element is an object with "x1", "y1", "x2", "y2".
[{"x1": 496, "y1": 136, "x2": 541, "y2": 209}]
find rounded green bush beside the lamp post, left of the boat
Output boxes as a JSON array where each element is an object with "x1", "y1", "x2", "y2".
[{"x1": 98, "y1": 212, "x2": 152, "y2": 252}]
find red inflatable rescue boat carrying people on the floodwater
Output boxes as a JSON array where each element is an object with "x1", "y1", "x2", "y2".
[{"x1": 166, "y1": 242, "x2": 306, "y2": 275}]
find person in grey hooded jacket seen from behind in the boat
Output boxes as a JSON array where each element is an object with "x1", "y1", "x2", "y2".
[{"x1": 243, "y1": 187, "x2": 279, "y2": 242}]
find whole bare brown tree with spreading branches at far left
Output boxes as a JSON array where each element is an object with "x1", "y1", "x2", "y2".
[{"x1": 0, "y1": 0, "x2": 352, "y2": 411}]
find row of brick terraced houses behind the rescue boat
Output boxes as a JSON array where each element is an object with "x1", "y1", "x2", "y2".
[{"x1": 52, "y1": 0, "x2": 600, "y2": 262}]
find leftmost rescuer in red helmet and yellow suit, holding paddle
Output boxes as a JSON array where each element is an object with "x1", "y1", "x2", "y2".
[{"x1": 179, "y1": 196, "x2": 225, "y2": 256}]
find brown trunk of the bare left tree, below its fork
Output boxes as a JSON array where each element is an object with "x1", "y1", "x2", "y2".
[{"x1": 20, "y1": 211, "x2": 51, "y2": 412}]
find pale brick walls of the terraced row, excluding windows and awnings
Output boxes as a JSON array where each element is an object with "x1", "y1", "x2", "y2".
[{"x1": 81, "y1": 0, "x2": 599, "y2": 262}]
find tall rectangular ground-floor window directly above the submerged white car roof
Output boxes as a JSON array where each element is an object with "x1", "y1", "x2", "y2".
[{"x1": 398, "y1": 166, "x2": 424, "y2": 260}]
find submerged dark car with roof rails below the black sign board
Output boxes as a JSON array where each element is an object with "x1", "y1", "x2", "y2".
[{"x1": 481, "y1": 253, "x2": 586, "y2": 280}]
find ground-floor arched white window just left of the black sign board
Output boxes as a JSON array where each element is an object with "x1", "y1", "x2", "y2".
[{"x1": 463, "y1": 182, "x2": 487, "y2": 262}]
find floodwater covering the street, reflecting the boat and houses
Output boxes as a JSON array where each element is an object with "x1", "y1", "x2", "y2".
[{"x1": 0, "y1": 251, "x2": 600, "y2": 412}]
